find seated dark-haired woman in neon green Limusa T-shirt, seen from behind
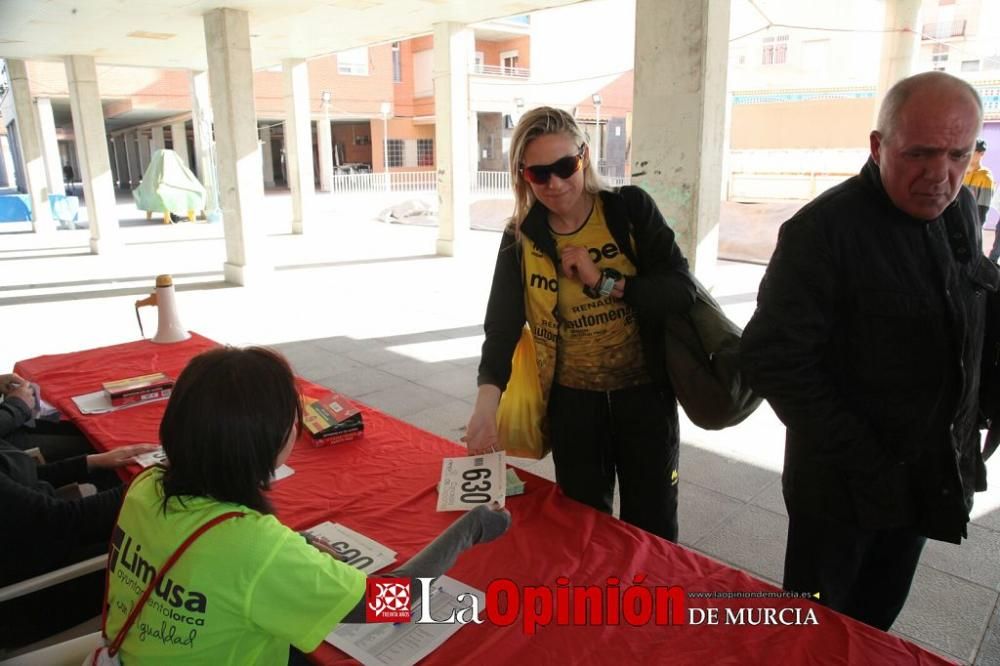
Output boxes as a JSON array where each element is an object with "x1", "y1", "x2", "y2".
[{"x1": 106, "y1": 348, "x2": 510, "y2": 664}]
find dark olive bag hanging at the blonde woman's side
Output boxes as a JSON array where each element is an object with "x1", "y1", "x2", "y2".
[{"x1": 665, "y1": 275, "x2": 762, "y2": 430}]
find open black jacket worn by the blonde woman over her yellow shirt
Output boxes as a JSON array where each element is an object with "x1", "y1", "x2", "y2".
[{"x1": 478, "y1": 186, "x2": 695, "y2": 394}]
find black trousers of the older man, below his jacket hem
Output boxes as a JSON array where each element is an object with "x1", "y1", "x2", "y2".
[{"x1": 784, "y1": 511, "x2": 927, "y2": 631}]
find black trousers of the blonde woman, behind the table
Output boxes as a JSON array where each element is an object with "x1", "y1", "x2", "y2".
[{"x1": 548, "y1": 384, "x2": 680, "y2": 541}]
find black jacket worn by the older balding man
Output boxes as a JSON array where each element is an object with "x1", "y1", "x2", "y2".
[{"x1": 741, "y1": 160, "x2": 1000, "y2": 543}]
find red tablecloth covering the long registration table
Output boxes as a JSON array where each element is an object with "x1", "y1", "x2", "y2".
[{"x1": 15, "y1": 335, "x2": 950, "y2": 666}]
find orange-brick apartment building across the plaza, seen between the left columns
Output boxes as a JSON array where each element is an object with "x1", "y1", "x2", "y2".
[{"x1": 0, "y1": 0, "x2": 634, "y2": 191}]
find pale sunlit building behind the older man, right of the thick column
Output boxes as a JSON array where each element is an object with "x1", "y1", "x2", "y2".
[{"x1": 726, "y1": 0, "x2": 1000, "y2": 221}]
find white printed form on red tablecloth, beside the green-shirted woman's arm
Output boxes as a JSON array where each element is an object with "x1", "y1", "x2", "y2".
[{"x1": 326, "y1": 576, "x2": 486, "y2": 666}]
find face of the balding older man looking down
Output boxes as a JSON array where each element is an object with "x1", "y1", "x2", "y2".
[{"x1": 870, "y1": 89, "x2": 979, "y2": 220}]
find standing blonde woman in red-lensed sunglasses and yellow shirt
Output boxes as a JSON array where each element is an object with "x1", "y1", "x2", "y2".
[{"x1": 464, "y1": 107, "x2": 695, "y2": 541}]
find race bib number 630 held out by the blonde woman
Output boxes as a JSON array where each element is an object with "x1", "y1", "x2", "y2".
[{"x1": 437, "y1": 451, "x2": 507, "y2": 511}]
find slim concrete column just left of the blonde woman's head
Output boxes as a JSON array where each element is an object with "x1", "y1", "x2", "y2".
[{"x1": 433, "y1": 22, "x2": 475, "y2": 256}]
